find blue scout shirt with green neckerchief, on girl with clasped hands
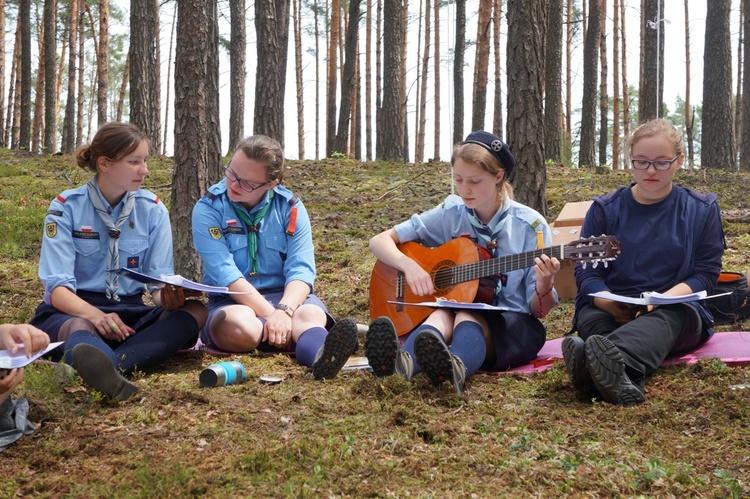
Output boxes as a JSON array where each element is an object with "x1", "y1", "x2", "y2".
[{"x1": 193, "y1": 179, "x2": 315, "y2": 291}]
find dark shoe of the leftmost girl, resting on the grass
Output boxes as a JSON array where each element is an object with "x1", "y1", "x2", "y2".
[{"x1": 71, "y1": 343, "x2": 138, "y2": 400}]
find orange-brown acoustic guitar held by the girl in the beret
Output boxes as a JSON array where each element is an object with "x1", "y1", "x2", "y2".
[{"x1": 370, "y1": 236, "x2": 620, "y2": 336}]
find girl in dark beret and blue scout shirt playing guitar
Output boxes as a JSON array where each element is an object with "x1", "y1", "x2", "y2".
[{"x1": 365, "y1": 131, "x2": 560, "y2": 394}]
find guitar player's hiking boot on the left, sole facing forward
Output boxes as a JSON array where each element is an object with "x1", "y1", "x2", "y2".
[{"x1": 365, "y1": 317, "x2": 414, "y2": 381}]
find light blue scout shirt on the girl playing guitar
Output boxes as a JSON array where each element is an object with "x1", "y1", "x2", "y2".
[{"x1": 394, "y1": 194, "x2": 557, "y2": 314}]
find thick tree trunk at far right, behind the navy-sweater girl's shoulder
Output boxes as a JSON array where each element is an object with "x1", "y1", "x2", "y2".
[{"x1": 701, "y1": 0, "x2": 736, "y2": 170}]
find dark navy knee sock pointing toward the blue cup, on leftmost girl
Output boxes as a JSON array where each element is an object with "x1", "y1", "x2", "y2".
[{"x1": 115, "y1": 310, "x2": 198, "y2": 373}]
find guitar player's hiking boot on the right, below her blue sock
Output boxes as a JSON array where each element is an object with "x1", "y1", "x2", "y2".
[{"x1": 414, "y1": 329, "x2": 466, "y2": 395}]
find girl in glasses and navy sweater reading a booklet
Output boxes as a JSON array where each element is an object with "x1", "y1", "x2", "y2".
[{"x1": 562, "y1": 119, "x2": 724, "y2": 406}]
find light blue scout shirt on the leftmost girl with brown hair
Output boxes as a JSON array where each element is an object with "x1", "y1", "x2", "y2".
[{"x1": 39, "y1": 185, "x2": 174, "y2": 304}]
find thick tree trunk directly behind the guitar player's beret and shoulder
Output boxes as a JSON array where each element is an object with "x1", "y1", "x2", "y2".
[{"x1": 507, "y1": 0, "x2": 548, "y2": 215}]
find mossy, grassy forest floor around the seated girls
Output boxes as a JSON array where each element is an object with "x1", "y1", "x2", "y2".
[{"x1": 0, "y1": 151, "x2": 750, "y2": 497}]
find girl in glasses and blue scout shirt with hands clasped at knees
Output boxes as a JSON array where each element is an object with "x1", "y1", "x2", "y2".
[{"x1": 193, "y1": 135, "x2": 357, "y2": 379}]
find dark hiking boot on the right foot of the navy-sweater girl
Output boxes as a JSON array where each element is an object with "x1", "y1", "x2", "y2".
[{"x1": 586, "y1": 335, "x2": 646, "y2": 406}]
